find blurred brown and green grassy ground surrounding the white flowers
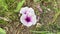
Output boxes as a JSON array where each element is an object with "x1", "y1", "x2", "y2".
[{"x1": 0, "y1": 0, "x2": 60, "y2": 34}]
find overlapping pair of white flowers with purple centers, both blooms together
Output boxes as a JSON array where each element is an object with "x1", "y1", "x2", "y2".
[{"x1": 20, "y1": 7, "x2": 37, "y2": 27}]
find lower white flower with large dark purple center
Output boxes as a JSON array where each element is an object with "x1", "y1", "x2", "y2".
[{"x1": 20, "y1": 15, "x2": 36, "y2": 27}]
